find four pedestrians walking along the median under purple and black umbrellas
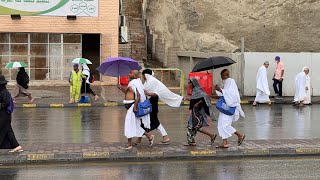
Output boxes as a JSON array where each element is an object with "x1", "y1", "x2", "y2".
[{"x1": 118, "y1": 69, "x2": 245, "y2": 150}]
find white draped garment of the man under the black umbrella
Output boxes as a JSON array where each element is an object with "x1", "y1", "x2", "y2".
[{"x1": 218, "y1": 78, "x2": 244, "y2": 139}]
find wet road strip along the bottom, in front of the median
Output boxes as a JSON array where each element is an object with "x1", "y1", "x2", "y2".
[{"x1": 0, "y1": 157, "x2": 320, "y2": 180}]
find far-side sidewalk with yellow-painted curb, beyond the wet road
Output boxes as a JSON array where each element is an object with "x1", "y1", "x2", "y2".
[{"x1": 8, "y1": 86, "x2": 320, "y2": 107}]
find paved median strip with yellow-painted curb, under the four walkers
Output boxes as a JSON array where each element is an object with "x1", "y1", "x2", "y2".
[{"x1": 0, "y1": 139, "x2": 320, "y2": 164}]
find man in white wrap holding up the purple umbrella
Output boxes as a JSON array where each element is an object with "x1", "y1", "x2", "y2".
[{"x1": 118, "y1": 70, "x2": 154, "y2": 150}]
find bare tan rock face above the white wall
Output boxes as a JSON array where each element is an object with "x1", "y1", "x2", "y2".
[{"x1": 146, "y1": 0, "x2": 320, "y2": 63}]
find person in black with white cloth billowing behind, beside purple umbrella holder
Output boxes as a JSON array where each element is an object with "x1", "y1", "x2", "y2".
[{"x1": 137, "y1": 69, "x2": 183, "y2": 144}]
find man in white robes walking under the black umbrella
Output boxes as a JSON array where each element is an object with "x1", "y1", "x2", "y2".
[{"x1": 215, "y1": 69, "x2": 245, "y2": 148}]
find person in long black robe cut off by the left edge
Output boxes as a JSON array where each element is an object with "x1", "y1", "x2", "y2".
[{"x1": 0, "y1": 75, "x2": 23, "y2": 153}]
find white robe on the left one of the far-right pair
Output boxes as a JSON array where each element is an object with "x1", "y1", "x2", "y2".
[{"x1": 294, "y1": 72, "x2": 307, "y2": 102}]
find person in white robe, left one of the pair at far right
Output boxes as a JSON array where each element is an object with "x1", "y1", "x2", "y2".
[{"x1": 294, "y1": 67, "x2": 309, "y2": 106}]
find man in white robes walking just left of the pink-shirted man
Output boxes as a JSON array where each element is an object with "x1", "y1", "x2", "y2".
[{"x1": 252, "y1": 61, "x2": 271, "y2": 106}]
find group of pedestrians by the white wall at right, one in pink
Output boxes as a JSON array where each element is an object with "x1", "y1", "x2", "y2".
[{"x1": 252, "y1": 56, "x2": 311, "y2": 107}]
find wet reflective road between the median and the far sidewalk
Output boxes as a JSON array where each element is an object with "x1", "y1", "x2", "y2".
[{"x1": 12, "y1": 105, "x2": 320, "y2": 144}]
